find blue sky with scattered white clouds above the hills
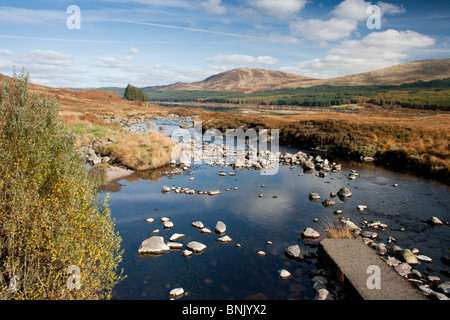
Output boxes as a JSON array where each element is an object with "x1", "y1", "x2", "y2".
[{"x1": 0, "y1": 0, "x2": 450, "y2": 88}]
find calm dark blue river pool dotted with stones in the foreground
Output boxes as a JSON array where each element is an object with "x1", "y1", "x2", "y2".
[{"x1": 102, "y1": 155, "x2": 450, "y2": 300}]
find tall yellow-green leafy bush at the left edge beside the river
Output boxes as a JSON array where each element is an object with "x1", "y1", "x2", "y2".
[{"x1": 0, "y1": 73, "x2": 123, "y2": 299}]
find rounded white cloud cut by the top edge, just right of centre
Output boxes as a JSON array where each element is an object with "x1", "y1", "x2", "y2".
[{"x1": 248, "y1": 0, "x2": 306, "y2": 18}]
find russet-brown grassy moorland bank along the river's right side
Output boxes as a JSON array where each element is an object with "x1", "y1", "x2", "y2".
[{"x1": 199, "y1": 112, "x2": 450, "y2": 184}]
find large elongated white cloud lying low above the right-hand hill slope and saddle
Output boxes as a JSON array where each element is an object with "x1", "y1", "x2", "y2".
[{"x1": 292, "y1": 29, "x2": 435, "y2": 77}]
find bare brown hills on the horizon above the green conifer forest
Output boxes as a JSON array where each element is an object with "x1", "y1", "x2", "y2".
[{"x1": 143, "y1": 59, "x2": 450, "y2": 92}]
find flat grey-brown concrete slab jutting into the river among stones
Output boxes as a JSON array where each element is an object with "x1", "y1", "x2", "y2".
[{"x1": 319, "y1": 239, "x2": 428, "y2": 300}]
